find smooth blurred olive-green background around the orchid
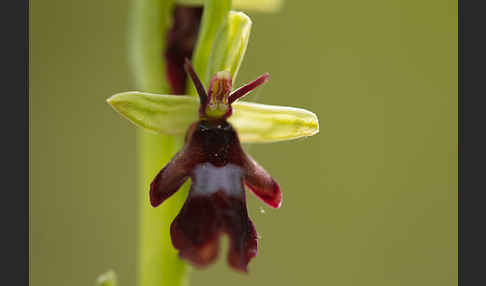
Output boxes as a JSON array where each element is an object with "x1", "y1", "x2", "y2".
[{"x1": 30, "y1": 0, "x2": 457, "y2": 286}]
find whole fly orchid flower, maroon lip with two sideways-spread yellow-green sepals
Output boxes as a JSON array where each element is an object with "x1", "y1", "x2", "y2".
[{"x1": 107, "y1": 57, "x2": 319, "y2": 272}]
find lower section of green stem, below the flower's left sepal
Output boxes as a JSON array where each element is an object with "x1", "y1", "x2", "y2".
[{"x1": 138, "y1": 134, "x2": 189, "y2": 286}]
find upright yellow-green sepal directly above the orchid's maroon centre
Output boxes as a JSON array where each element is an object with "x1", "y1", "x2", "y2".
[{"x1": 206, "y1": 11, "x2": 252, "y2": 82}]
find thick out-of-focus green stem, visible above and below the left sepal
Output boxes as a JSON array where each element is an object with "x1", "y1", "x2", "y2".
[{"x1": 130, "y1": 0, "x2": 187, "y2": 286}]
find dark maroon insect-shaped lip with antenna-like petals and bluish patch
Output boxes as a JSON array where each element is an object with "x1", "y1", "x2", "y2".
[{"x1": 150, "y1": 61, "x2": 282, "y2": 272}]
